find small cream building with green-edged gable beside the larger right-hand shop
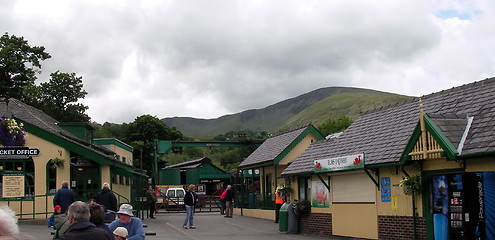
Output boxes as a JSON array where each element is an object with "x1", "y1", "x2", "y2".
[{"x1": 236, "y1": 123, "x2": 324, "y2": 220}]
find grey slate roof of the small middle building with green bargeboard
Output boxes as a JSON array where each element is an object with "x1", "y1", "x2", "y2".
[{"x1": 239, "y1": 126, "x2": 309, "y2": 168}]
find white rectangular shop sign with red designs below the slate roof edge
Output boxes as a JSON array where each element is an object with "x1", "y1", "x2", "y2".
[{"x1": 314, "y1": 153, "x2": 364, "y2": 173}]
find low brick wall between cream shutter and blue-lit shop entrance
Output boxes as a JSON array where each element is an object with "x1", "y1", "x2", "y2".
[{"x1": 378, "y1": 216, "x2": 426, "y2": 240}]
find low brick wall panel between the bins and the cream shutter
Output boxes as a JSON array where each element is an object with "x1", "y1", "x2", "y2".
[{"x1": 299, "y1": 213, "x2": 332, "y2": 236}]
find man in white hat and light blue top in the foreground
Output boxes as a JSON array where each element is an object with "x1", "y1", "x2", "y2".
[{"x1": 108, "y1": 204, "x2": 145, "y2": 240}]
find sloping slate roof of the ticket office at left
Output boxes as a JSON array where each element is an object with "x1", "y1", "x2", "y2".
[{"x1": 0, "y1": 98, "x2": 130, "y2": 166}]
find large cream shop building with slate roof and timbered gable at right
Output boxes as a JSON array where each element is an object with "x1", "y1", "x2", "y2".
[{"x1": 282, "y1": 78, "x2": 495, "y2": 239}]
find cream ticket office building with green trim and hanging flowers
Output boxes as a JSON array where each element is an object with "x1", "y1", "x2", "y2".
[{"x1": 0, "y1": 98, "x2": 146, "y2": 218}]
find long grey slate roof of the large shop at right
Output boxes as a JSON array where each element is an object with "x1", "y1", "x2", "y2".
[{"x1": 282, "y1": 78, "x2": 495, "y2": 175}]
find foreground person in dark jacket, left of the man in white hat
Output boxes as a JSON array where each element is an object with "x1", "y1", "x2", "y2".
[{"x1": 60, "y1": 201, "x2": 114, "y2": 240}]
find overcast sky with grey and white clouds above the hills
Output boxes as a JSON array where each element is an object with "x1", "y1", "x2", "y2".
[{"x1": 0, "y1": 0, "x2": 495, "y2": 123}]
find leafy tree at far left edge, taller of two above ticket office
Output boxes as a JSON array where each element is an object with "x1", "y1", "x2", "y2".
[{"x1": 0, "y1": 33, "x2": 51, "y2": 101}]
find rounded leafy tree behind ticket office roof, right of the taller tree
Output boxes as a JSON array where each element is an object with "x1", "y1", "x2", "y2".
[{"x1": 36, "y1": 71, "x2": 90, "y2": 122}]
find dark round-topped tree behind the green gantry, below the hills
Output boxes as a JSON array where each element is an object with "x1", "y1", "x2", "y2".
[{"x1": 123, "y1": 115, "x2": 182, "y2": 173}]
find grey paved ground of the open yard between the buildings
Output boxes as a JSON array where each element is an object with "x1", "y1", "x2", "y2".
[{"x1": 19, "y1": 213, "x2": 340, "y2": 240}]
